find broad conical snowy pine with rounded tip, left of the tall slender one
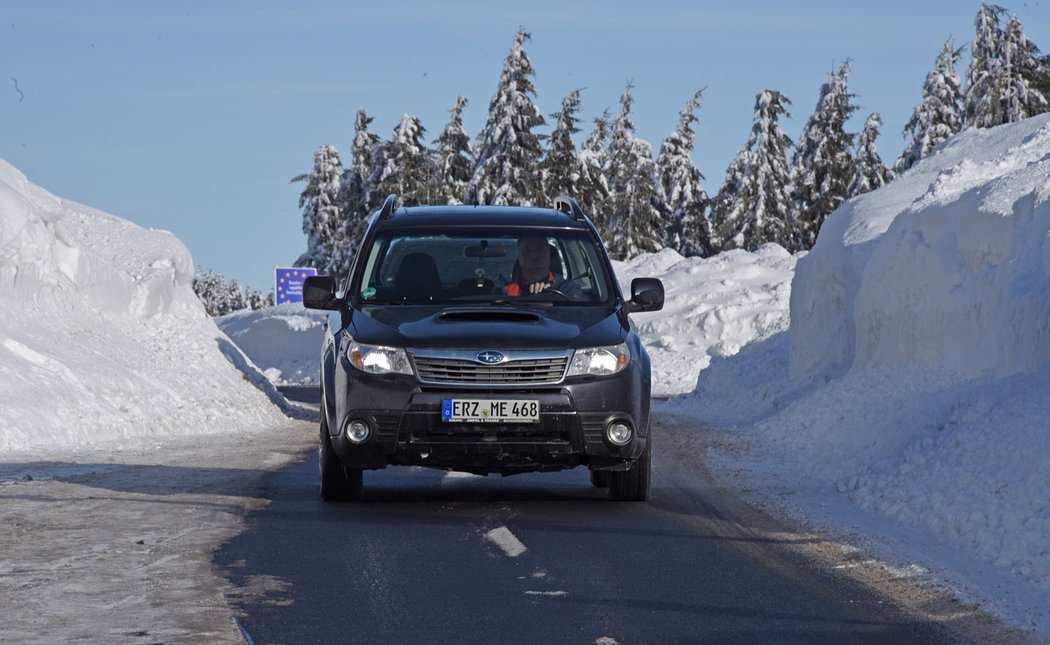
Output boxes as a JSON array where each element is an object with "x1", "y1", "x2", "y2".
[{"x1": 713, "y1": 89, "x2": 801, "y2": 252}]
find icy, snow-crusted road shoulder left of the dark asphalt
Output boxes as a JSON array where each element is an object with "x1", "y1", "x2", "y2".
[{"x1": 0, "y1": 420, "x2": 316, "y2": 643}]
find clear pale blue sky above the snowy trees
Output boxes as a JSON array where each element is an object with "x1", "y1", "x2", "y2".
[{"x1": 0, "y1": 0, "x2": 1050, "y2": 290}]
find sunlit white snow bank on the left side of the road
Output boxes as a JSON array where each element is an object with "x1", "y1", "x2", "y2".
[{"x1": 0, "y1": 160, "x2": 287, "y2": 451}]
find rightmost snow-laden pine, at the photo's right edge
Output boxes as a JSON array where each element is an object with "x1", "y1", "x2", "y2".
[{"x1": 1002, "y1": 16, "x2": 1050, "y2": 123}]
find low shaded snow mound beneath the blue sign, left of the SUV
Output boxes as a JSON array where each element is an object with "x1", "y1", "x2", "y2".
[{"x1": 215, "y1": 304, "x2": 327, "y2": 386}]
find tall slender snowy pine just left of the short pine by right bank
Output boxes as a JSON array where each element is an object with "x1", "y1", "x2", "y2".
[{"x1": 792, "y1": 60, "x2": 857, "y2": 248}]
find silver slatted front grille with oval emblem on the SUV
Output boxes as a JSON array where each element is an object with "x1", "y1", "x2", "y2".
[{"x1": 414, "y1": 352, "x2": 569, "y2": 386}]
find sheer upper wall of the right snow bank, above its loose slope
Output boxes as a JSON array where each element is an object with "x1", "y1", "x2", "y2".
[{"x1": 791, "y1": 116, "x2": 1050, "y2": 380}]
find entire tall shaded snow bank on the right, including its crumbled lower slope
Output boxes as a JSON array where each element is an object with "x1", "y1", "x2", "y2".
[{"x1": 681, "y1": 115, "x2": 1050, "y2": 632}]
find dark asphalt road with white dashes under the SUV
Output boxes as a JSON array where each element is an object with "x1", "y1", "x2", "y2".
[{"x1": 216, "y1": 407, "x2": 956, "y2": 645}]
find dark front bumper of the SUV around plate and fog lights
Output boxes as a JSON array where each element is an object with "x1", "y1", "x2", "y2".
[{"x1": 328, "y1": 366, "x2": 649, "y2": 474}]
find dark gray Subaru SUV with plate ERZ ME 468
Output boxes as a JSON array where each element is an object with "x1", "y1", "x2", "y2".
[{"x1": 302, "y1": 195, "x2": 664, "y2": 501}]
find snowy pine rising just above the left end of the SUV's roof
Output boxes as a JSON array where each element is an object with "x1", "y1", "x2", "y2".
[{"x1": 376, "y1": 115, "x2": 433, "y2": 206}]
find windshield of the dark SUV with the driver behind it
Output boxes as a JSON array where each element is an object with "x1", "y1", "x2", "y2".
[{"x1": 354, "y1": 228, "x2": 613, "y2": 306}]
